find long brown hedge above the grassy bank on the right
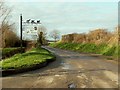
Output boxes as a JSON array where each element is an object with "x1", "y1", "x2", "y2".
[{"x1": 62, "y1": 29, "x2": 118, "y2": 44}]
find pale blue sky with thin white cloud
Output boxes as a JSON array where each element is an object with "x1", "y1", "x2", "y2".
[{"x1": 6, "y1": 0, "x2": 118, "y2": 40}]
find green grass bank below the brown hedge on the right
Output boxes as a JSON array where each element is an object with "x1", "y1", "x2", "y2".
[{"x1": 50, "y1": 42, "x2": 120, "y2": 57}]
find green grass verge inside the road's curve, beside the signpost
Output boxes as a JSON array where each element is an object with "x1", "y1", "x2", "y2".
[{"x1": 0, "y1": 48, "x2": 54, "y2": 70}]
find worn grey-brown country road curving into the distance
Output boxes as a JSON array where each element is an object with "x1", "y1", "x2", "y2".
[{"x1": 2, "y1": 46, "x2": 118, "y2": 88}]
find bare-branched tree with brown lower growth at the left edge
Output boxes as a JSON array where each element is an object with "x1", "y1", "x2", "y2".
[{"x1": 0, "y1": 0, "x2": 18, "y2": 47}]
